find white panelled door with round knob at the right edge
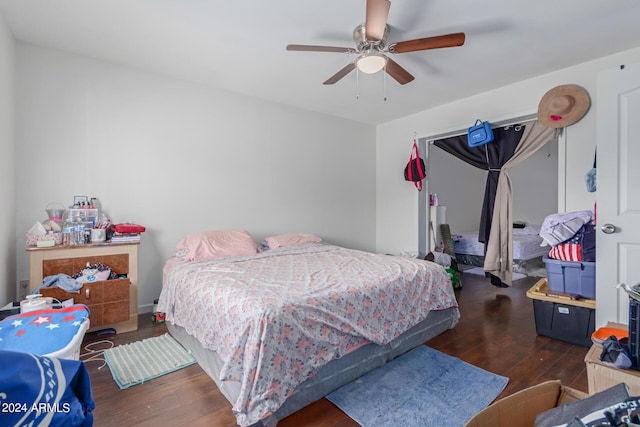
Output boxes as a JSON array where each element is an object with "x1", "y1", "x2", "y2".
[{"x1": 596, "y1": 64, "x2": 640, "y2": 328}]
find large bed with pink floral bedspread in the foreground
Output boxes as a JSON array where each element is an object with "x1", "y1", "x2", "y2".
[{"x1": 158, "y1": 232, "x2": 460, "y2": 426}]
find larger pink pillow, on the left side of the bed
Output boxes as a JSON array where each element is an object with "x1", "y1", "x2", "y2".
[{"x1": 176, "y1": 230, "x2": 258, "y2": 261}]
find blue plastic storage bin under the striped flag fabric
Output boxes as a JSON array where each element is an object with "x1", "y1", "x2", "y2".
[{"x1": 543, "y1": 255, "x2": 596, "y2": 299}]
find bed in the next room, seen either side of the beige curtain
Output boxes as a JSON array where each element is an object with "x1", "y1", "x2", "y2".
[{"x1": 452, "y1": 225, "x2": 549, "y2": 275}]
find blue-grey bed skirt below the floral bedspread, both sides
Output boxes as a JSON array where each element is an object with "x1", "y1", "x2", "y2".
[{"x1": 167, "y1": 308, "x2": 459, "y2": 427}]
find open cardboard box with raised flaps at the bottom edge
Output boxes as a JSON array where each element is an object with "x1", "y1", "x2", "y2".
[{"x1": 465, "y1": 380, "x2": 588, "y2": 427}]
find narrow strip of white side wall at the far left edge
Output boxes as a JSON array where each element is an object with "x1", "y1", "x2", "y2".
[{"x1": 0, "y1": 15, "x2": 16, "y2": 305}]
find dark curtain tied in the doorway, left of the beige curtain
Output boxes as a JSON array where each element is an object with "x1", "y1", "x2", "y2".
[{"x1": 433, "y1": 126, "x2": 525, "y2": 244}]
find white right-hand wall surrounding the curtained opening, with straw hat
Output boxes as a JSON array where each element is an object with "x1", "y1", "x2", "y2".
[{"x1": 376, "y1": 48, "x2": 640, "y2": 253}]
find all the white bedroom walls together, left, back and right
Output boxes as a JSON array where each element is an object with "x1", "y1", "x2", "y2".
[{"x1": 8, "y1": 39, "x2": 640, "y2": 314}]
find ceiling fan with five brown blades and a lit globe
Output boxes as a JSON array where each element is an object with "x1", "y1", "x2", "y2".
[{"x1": 287, "y1": 0, "x2": 465, "y2": 85}]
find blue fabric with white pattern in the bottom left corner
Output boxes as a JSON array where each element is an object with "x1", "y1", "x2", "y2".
[{"x1": 0, "y1": 350, "x2": 95, "y2": 427}]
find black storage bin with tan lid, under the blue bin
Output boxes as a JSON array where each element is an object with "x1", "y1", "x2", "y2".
[{"x1": 533, "y1": 299, "x2": 596, "y2": 347}]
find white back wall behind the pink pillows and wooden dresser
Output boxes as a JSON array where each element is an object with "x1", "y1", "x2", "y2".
[{"x1": 16, "y1": 43, "x2": 375, "y2": 309}]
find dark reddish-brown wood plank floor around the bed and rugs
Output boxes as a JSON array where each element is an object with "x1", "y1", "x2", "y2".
[{"x1": 83, "y1": 274, "x2": 588, "y2": 427}]
